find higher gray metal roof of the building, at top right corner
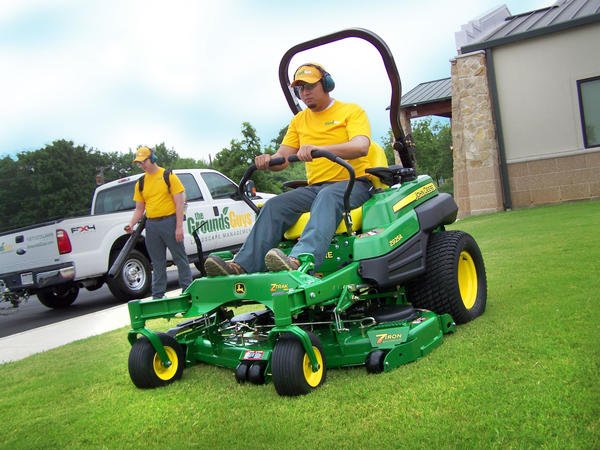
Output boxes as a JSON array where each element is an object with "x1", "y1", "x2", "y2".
[{"x1": 461, "y1": 0, "x2": 600, "y2": 53}]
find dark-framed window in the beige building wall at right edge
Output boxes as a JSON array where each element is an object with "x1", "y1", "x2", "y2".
[{"x1": 577, "y1": 77, "x2": 600, "y2": 148}]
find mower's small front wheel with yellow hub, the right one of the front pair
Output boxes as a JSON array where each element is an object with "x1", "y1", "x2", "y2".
[{"x1": 271, "y1": 332, "x2": 327, "y2": 396}]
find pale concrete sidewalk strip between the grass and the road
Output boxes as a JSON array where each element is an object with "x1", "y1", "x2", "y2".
[{"x1": 0, "y1": 289, "x2": 181, "y2": 364}]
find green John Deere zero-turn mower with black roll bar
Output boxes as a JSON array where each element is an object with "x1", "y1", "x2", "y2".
[{"x1": 124, "y1": 29, "x2": 487, "y2": 396}]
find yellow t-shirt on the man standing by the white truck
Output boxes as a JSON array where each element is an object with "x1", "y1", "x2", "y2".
[{"x1": 133, "y1": 167, "x2": 185, "y2": 219}]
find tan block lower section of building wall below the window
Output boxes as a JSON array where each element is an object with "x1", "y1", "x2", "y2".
[{"x1": 508, "y1": 151, "x2": 600, "y2": 208}]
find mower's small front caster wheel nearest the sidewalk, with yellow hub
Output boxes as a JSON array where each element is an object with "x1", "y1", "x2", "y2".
[{"x1": 129, "y1": 333, "x2": 185, "y2": 389}]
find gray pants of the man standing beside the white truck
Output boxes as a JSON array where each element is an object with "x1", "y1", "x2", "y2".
[{"x1": 146, "y1": 215, "x2": 192, "y2": 298}]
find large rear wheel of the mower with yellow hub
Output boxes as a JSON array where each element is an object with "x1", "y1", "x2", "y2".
[{"x1": 406, "y1": 231, "x2": 487, "y2": 324}]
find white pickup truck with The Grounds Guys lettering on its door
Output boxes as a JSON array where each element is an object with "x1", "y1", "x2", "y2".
[{"x1": 0, "y1": 169, "x2": 273, "y2": 308}]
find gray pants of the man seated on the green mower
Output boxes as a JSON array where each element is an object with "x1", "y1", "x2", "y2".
[{"x1": 235, "y1": 180, "x2": 373, "y2": 273}]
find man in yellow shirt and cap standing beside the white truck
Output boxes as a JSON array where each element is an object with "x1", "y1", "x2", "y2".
[{"x1": 126, "y1": 147, "x2": 192, "y2": 298}]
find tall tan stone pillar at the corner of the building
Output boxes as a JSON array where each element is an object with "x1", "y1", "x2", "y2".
[{"x1": 451, "y1": 51, "x2": 503, "y2": 217}]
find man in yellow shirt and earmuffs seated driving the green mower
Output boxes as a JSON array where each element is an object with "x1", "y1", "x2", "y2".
[{"x1": 205, "y1": 63, "x2": 372, "y2": 276}]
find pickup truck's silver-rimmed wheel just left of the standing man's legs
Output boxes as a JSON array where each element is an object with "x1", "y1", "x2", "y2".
[{"x1": 106, "y1": 250, "x2": 152, "y2": 301}]
